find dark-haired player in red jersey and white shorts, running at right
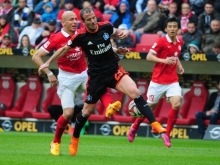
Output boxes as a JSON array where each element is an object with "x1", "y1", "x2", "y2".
[{"x1": 128, "y1": 17, "x2": 184, "y2": 147}]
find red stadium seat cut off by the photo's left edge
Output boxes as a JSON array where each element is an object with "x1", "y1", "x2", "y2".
[{"x1": 0, "y1": 74, "x2": 16, "y2": 116}]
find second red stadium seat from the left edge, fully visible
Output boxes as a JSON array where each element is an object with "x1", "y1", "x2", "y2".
[{"x1": 5, "y1": 75, "x2": 42, "y2": 118}]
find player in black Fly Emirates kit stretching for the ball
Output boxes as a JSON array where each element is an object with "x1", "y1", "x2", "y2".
[{"x1": 39, "y1": 8, "x2": 166, "y2": 156}]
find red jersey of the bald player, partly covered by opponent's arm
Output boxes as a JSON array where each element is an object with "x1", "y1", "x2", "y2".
[{"x1": 41, "y1": 29, "x2": 87, "y2": 73}]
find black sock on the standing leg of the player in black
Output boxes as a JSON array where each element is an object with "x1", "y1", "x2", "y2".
[{"x1": 73, "y1": 111, "x2": 88, "y2": 138}]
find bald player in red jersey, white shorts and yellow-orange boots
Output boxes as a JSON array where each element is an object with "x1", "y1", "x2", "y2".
[{"x1": 32, "y1": 11, "x2": 123, "y2": 155}]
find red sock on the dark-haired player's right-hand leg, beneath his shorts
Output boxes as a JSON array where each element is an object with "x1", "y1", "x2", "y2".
[{"x1": 166, "y1": 109, "x2": 179, "y2": 136}]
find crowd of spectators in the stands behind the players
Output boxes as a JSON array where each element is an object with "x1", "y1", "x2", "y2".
[{"x1": 0, "y1": 0, "x2": 220, "y2": 54}]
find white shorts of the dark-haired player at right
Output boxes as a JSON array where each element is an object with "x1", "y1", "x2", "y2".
[{"x1": 147, "y1": 81, "x2": 182, "y2": 104}]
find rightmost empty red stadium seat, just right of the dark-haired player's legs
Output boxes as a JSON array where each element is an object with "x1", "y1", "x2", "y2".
[{"x1": 176, "y1": 81, "x2": 209, "y2": 125}]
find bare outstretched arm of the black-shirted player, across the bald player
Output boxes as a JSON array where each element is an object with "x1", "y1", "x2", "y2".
[{"x1": 38, "y1": 45, "x2": 71, "y2": 75}]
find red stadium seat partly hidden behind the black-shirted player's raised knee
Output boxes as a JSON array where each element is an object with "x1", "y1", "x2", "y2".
[{"x1": 114, "y1": 79, "x2": 149, "y2": 122}]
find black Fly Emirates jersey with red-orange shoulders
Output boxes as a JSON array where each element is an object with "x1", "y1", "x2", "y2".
[{"x1": 68, "y1": 22, "x2": 119, "y2": 76}]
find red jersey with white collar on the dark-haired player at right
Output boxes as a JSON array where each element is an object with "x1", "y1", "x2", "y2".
[{"x1": 150, "y1": 35, "x2": 183, "y2": 84}]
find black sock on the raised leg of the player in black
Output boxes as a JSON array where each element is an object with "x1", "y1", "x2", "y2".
[{"x1": 134, "y1": 95, "x2": 156, "y2": 123}]
